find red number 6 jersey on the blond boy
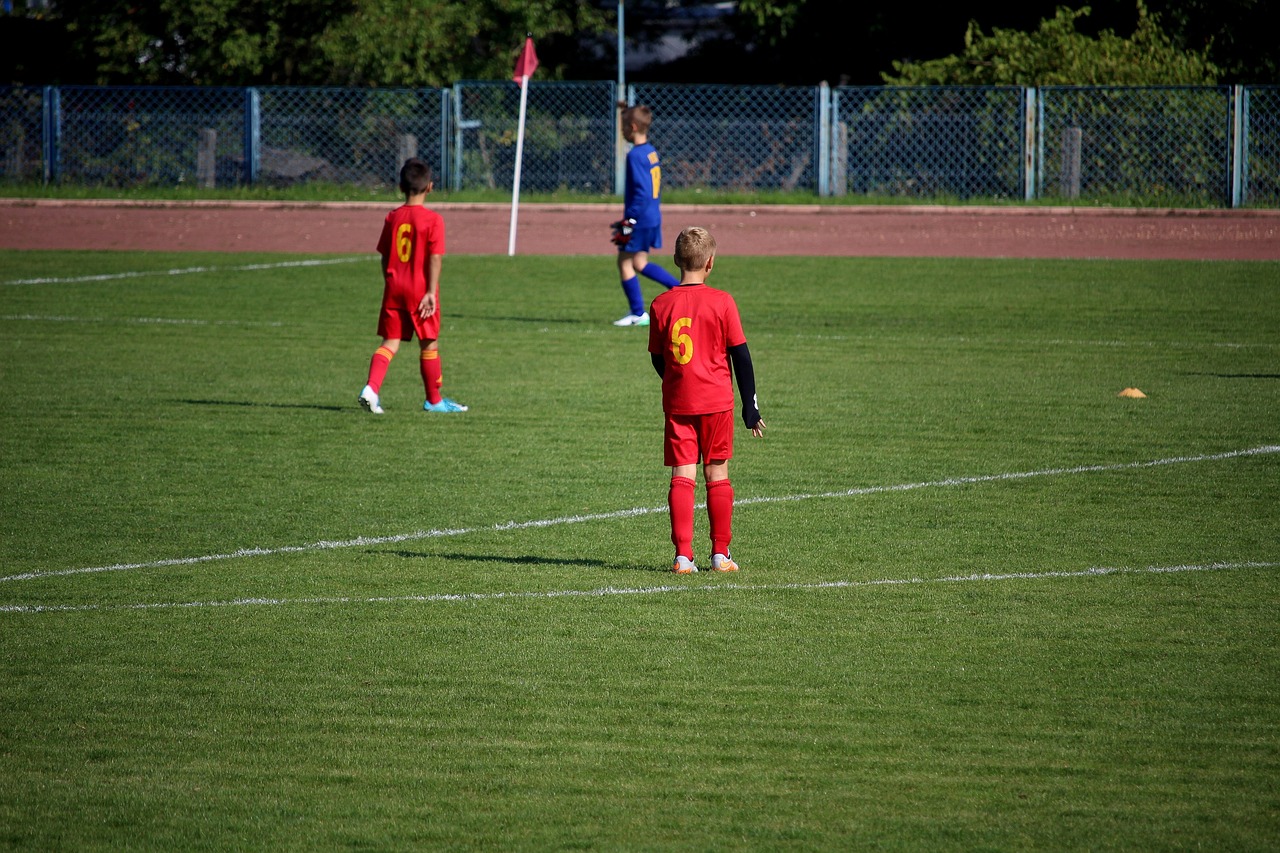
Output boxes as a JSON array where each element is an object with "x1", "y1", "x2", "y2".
[{"x1": 649, "y1": 284, "x2": 746, "y2": 415}]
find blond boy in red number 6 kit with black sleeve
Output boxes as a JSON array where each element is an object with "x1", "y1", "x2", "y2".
[{"x1": 649, "y1": 227, "x2": 764, "y2": 575}]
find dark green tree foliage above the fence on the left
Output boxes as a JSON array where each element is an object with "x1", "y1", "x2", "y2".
[{"x1": 36, "y1": 0, "x2": 604, "y2": 87}]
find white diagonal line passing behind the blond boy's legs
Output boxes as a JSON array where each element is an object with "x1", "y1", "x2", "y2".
[{"x1": 0, "y1": 444, "x2": 1280, "y2": 583}]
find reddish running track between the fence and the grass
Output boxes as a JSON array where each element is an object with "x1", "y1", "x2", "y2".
[{"x1": 0, "y1": 199, "x2": 1280, "y2": 260}]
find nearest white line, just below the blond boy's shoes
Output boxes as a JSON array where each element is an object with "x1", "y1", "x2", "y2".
[{"x1": 0, "y1": 562, "x2": 1280, "y2": 613}]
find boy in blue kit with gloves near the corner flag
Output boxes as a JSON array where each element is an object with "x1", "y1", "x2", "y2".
[{"x1": 613, "y1": 104, "x2": 680, "y2": 325}]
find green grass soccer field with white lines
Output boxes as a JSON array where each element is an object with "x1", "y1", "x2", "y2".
[{"x1": 0, "y1": 245, "x2": 1280, "y2": 850}]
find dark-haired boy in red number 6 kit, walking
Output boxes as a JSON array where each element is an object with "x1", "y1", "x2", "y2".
[{"x1": 358, "y1": 158, "x2": 467, "y2": 415}]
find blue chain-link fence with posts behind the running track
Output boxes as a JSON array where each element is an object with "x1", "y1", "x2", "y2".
[{"x1": 0, "y1": 82, "x2": 1280, "y2": 206}]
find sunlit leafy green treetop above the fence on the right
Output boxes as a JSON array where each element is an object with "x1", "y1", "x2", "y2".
[{"x1": 882, "y1": 0, "x2": 1220, "y2": 86}]
